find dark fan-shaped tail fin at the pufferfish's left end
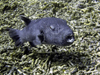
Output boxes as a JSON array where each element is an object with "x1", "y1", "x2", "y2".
[{"x1": 7, "y1": 28, "x2": 23, "y2": 46}]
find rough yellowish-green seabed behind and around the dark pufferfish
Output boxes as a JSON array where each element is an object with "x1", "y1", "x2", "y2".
[{"x1": 0, "y1": 0, "x2": 100, "y2": 75}]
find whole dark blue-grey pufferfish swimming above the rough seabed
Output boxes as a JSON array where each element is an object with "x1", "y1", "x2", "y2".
[{"x1": 8, "y1": 15, "x2": 74, "y2": 47}]
